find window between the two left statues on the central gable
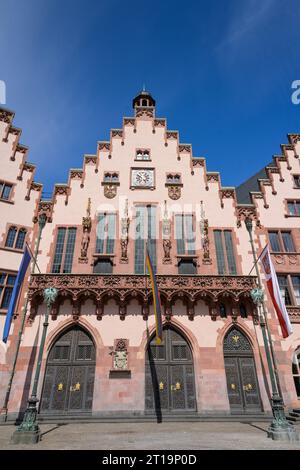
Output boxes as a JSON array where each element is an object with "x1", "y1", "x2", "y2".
[{"x1": 96, "y1": 213, "x2": 116, "y2": 254}]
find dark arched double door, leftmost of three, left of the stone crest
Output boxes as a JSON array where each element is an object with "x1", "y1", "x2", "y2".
[{"x1": 40, "y1": 326, "x2": 96, "y2": 414}]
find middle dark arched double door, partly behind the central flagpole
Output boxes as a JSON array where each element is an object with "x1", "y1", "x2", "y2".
[{"x1": 145, "y1": 327, "x2": 196, "y2": 415}]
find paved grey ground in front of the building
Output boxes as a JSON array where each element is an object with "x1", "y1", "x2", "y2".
[{"x1": 0, "y1": 422, "x2": 300, "y2": 450}]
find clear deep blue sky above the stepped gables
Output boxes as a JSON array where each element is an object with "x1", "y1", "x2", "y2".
[{"x1": 0, "y1": 0, "x2": 300, "y2": 195}]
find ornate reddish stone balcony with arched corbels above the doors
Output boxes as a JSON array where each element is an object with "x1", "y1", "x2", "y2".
[{"x1": 28, "y1": 274, "x2": 255, "y2": 319}]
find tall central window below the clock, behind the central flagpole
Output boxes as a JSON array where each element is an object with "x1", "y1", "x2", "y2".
[{"x1": 134, "y1": 206, "x2": 157, "y2": 274}]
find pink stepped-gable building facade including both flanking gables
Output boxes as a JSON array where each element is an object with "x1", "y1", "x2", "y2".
[{"x1": 0, "y1": 92, "x2": 300, "y2": 418}]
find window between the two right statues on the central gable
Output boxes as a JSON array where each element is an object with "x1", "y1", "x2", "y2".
[{"x1": 175, "y1": 214, "x2": 195, "y2": 255}]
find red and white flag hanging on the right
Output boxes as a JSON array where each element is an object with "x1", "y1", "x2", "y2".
[{"x1": 260, "y1": 245, "x2": 293, "y2": 338}]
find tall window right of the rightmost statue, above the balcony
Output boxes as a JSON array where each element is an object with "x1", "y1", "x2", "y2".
[{"x1": 214, "y1": 230, "x2": 237, "y2": 275}]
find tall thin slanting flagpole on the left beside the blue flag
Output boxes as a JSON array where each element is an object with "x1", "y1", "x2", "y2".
[{"x1": 1, "y1": 214, "x2": 47, "y2": 422}]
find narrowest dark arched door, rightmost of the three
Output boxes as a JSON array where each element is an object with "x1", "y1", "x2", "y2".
[{"x1": 224, "y1": 327, "x2": 262, "y2": 413}]
